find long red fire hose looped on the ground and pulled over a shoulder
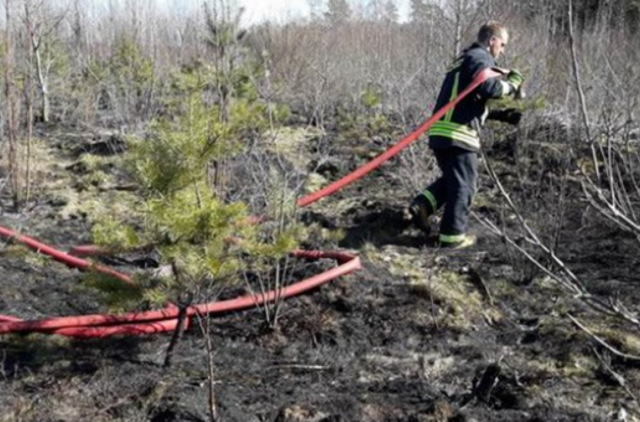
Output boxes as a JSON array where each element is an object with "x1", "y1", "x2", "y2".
[{"x1": 0, "y1": 69, "x2": 502, "y2": 338}]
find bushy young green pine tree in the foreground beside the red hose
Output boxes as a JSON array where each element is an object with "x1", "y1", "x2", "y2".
[{"x1": 92, "y1": 59, "x2": 304, "y2": 365}]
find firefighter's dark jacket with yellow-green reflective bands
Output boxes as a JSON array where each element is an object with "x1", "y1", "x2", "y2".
[{"x1": 429, "y1": 43, "x2": 505, "y2": 151}]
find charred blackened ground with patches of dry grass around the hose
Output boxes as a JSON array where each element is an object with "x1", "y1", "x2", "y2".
[{"x1": 0, "y1": 119, "x2": 640, "y2": 422}]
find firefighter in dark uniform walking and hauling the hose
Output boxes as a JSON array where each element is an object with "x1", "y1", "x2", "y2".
[{"x1": 409, "y1": 22, "x2": 523, "y2": 249}]
